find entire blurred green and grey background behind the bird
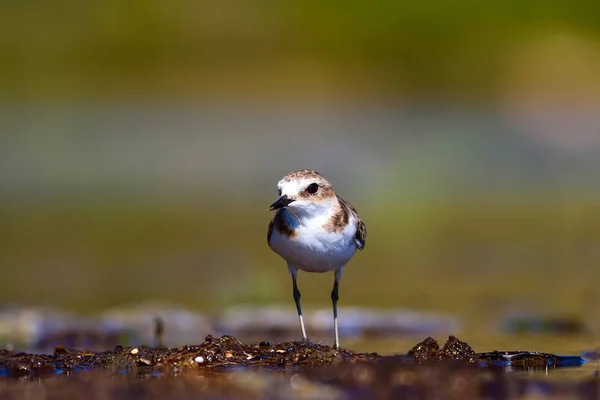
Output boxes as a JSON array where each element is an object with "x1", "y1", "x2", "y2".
[{"x1": 0, "y1": 0, "x2": 600, "y2": 336}]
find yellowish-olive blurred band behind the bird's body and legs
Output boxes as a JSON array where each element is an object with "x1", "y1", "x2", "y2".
[{"x1": 0, "y1": 201, "x2": 600, "y2": 329}]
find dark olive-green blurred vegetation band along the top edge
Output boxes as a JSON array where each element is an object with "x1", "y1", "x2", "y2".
[{"x1": 0, "y1": 0, "x2": 600, "y2": 100}]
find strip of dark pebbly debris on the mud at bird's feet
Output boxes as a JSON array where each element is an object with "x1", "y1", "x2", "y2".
[{"x1": 0, "y1": 335, "x2": 584, "y2": 377}]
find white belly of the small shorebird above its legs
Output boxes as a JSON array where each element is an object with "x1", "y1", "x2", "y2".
[{"x1": 269, "y1": 228, "x2": 356, "y2": 272}]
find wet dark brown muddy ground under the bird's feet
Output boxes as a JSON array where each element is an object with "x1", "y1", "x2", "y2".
[{"x1": 0, "y1": 336, "x2": 600, "y2": 400}]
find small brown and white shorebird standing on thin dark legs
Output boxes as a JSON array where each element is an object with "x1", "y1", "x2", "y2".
[{"x1": 267, "y1": 169, "x2": 367, "y2": 349}]
